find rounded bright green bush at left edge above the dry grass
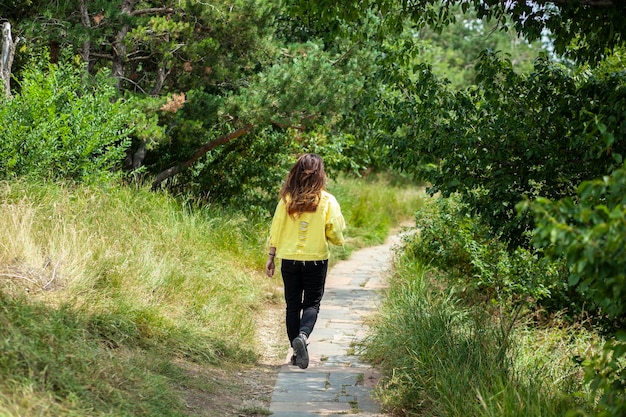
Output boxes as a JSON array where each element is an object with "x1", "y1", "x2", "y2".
[{"x1": 0, "y1": 57, "x2": 130, "y2": 182}]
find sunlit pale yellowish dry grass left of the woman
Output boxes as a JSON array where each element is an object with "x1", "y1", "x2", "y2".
[{"x1": 2, "y1": 181, "x2": 262, "y2": 352}]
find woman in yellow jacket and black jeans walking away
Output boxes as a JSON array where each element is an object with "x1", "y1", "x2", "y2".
[{"x1": 265, "y1": 154, "x2": 345, "y2": 369}]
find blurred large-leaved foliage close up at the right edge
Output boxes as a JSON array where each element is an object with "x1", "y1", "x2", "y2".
[{"x1": 530, "y1": 167, "x2": 626, "y2": 325}]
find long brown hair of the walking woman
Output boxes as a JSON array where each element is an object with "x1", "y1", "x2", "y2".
[{"x1": 280, "y1": 153, "x2": 326, "y2": 218}]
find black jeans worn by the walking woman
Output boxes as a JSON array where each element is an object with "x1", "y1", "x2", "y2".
[{"x1": 280, "y1": 259, "x2": 328, "y2": 342}]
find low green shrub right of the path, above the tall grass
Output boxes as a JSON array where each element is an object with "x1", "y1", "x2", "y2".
[{"x1": 406, "y1": 195, "x2": 564, "y2": 303}]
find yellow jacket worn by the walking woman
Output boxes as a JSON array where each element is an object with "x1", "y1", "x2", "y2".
[{"x1": 269, "y1": 191, "x2": 346, "y2": 261}]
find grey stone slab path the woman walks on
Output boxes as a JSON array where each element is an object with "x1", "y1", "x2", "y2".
[{"x1": 270, "y1": 234, "x2": 397, "y2": 417}]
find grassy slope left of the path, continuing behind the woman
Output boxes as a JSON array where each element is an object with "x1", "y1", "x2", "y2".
[{"x1": 0, "y1": 177, "x2": 419, "y2": 417}]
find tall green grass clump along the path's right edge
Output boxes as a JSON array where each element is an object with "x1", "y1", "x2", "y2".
[{"x1": 362, "y1": 256, "x2": 590, "y2": 417}]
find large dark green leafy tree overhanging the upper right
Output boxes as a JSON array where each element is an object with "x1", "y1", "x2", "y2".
[{"x1": 276, "y1": 0, "x2": 626, "y2": 247}]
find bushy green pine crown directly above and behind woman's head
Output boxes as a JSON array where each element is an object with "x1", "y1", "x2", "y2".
[{"x1": 149, "y1": 42, "x2": 376, "y2": 200}]
